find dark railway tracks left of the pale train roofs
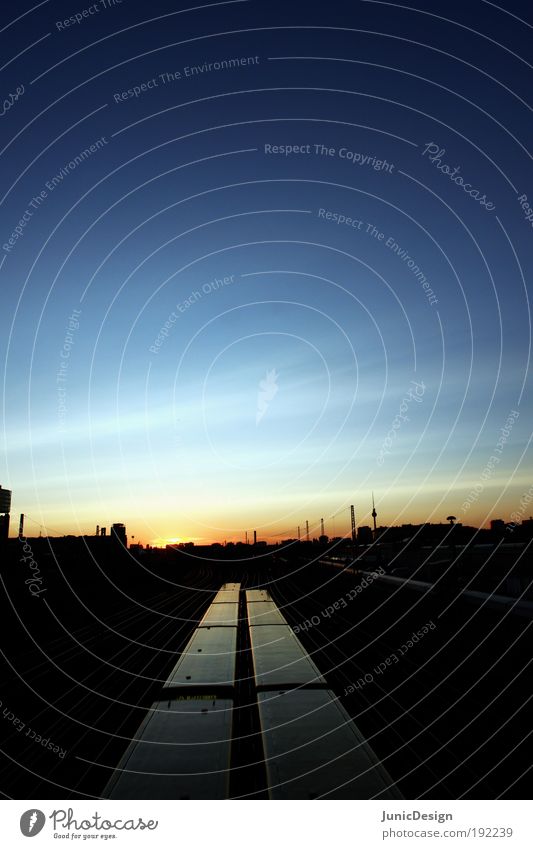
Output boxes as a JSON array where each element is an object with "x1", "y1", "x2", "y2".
[{"x1": 0, "y1": 569, "x2": 219, "y2": 799}]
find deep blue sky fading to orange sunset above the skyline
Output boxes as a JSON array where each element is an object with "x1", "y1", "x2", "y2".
[{"x1": 0, "y1": 0, "x2": 533, "y2": 543}]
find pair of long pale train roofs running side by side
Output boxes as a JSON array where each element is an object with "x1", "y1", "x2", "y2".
[{"x1": 103, "y1": 584, "x2": 402, "y2": 799}]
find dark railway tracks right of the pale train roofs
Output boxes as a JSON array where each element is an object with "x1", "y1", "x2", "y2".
[{"x1": 272, "y1": 564, "x2": 532, "y2": 798}]
